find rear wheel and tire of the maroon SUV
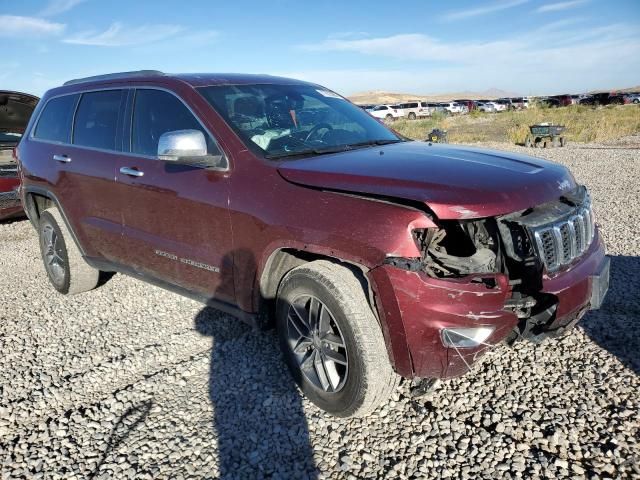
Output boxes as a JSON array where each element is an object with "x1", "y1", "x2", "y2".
[{"x1": 38, "y1": 207, "x2": 100, "y2": 295}]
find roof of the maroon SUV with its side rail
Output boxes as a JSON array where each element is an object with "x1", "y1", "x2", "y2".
[{"x1": 45, "y1": 70, "x2": 318, "y2": 95}]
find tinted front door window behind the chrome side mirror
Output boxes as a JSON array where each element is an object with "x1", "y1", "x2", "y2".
[{"x1": 131, "y1": 89, "x2": 220, "y2": 157}]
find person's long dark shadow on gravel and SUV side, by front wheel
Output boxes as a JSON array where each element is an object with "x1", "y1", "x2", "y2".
[{"x1": 195, "y1": 250, "x2": 318, "y2": 479}]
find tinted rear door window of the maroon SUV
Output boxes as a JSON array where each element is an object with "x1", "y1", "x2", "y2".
[{"x1": 73, "y1": 90, "x2": 122, "y2": 150}]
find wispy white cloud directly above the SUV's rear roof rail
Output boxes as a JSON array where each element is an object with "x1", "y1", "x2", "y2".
[{"x1": 63, "y1": 22, "x2": 185, "y2": 47}]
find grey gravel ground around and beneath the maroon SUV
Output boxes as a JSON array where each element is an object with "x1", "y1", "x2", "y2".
[{"x1": 0, "y1": 137, "x2": 640, "y2": 480}]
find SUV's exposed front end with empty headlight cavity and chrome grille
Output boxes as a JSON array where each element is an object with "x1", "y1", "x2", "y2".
[{"x1": 390, "y1": 186, "x2": 594, "y2": 339}]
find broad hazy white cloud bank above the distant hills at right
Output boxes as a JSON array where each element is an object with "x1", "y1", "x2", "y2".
[{"x1": 296, "y1": 23, "x2": 640, "y2": 94}]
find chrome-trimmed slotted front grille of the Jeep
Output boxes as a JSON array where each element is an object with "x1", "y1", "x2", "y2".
[{"x1": 531, "y1": 204, "x2": 595, "y2": 272}]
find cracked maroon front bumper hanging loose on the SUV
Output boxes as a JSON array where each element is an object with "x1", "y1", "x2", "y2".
[{"x1": 369, "y1": 230, "x2": 608, "y2": 378}]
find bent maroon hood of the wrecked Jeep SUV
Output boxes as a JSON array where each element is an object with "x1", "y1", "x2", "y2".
[{"x1": 278, "y1": 142, "x2": 576, "y2": 219}]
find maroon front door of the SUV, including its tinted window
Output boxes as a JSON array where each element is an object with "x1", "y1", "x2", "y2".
[{"x1": 117, "y1": 88, "x2": 235, "y2": 303}]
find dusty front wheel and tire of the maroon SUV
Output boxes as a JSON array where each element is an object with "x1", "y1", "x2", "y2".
[{"x1": 276, "y1": 260, "x2": 400, "y2": 417}]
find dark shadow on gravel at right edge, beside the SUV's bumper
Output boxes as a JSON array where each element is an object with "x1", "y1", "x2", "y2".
[{"x1": 580, "y1": 255, "x2": 640, "y2": 375}]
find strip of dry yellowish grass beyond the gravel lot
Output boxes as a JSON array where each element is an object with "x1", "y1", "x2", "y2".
[{"x1": 391, "y1": 105, "x2": 640, "y2": 143}]
